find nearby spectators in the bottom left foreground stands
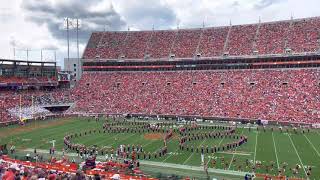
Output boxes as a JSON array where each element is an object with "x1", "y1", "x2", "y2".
[{"x1": 0, "y1": 156, "x2": 153, "y2": 180}]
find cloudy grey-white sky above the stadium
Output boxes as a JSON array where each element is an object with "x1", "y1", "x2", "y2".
[{"x1": 0, "y1": 0, "x2": 320, "y2": 68}]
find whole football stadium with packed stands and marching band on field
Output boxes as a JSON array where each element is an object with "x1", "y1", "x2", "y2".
[{"x1": 0, "y1": 1, "x2": 320, "y2": 180}]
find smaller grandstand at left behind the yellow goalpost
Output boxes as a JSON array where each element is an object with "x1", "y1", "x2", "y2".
[{"x1": 0, "y1": 59, "x2": 72, "y2": 125}]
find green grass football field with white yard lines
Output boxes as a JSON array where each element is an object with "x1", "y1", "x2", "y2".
[{"x1": 0, "y1": 118, "x2": 320, "y2": 179}]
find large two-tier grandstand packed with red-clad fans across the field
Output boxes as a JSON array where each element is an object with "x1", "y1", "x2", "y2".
[{"x1": 76, "y1": 17, "x2": 320, "y2": 123}]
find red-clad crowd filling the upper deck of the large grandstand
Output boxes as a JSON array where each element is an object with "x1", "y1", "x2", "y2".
[{"x1": 83, "y1": 18, "x2": 320, "y2": 59}]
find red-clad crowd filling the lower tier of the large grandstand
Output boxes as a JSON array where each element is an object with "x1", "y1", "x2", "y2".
[{"x1": 71, "y1": 69, "x2": 320, "y2": 122}]
